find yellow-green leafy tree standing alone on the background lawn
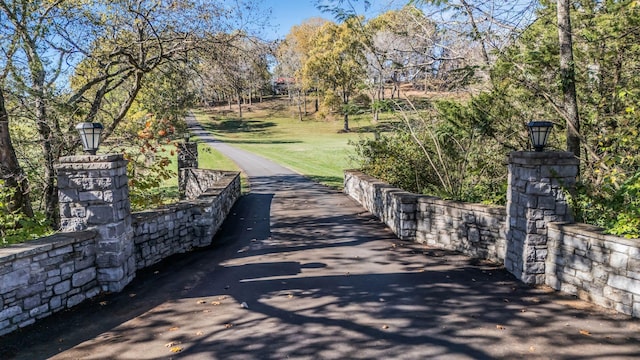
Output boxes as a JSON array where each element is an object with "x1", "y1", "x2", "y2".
[{"x1": 303, "y1": 18, "x2": 366, "y2": 131}]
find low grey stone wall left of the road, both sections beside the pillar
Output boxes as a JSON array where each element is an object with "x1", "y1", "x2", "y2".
[{"x1": 0, "y1": 170, "x2": 240, "y2": 335}]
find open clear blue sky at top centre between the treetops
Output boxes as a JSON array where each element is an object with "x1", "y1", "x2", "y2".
[{"x1": 262, "y1": 0, "x2": 406, "y2": 40}]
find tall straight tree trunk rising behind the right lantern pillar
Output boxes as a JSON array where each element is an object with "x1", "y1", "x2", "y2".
[{"x1": 558, "y1": 0, "x2": 580, "y2": 158}]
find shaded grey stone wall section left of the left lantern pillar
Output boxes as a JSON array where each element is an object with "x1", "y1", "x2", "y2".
[{"x1": 0, "y1": 230, "x2": 100, "y2": 335}]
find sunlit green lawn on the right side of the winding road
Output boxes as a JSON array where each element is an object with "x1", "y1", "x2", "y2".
[{"x1": 194, "y1": 99, "x2": 378, "y2": 189}]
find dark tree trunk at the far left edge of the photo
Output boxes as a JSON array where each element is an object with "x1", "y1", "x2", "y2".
[{"x1": 0, "y1": 89, "x2": 33, "y2": 217}]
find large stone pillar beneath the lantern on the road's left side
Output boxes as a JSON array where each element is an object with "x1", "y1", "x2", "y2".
[{"x1": 56, "y1": 155, "x2": 136, "y2": 292}]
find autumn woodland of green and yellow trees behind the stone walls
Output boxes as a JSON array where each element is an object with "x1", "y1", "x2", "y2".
[{"x1": 0, "y1": 0, "x2": 640, "y2": 239}]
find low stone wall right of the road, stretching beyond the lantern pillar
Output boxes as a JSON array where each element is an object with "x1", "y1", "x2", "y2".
[{"x1": 344, "y1": 170, "x2": 506, "y2": 261}]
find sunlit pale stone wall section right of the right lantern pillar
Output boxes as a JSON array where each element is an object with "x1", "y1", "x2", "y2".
[{"x1": 546, "y1": 223, "x2": 640, "y2": 317}]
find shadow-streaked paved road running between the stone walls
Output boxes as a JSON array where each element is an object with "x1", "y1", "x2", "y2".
[{"x1": 0, "y1": 114, "x2": 640, "y2": 359}]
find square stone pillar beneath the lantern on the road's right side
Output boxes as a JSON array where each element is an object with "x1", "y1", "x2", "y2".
[{"x1": 505, "y1": 151, "x2": 580, "y2": 285}]
